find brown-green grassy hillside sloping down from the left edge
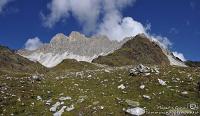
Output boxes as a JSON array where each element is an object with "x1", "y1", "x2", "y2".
[{"x1": 0, "y1": 46, "x2": 45, "y2": 72}]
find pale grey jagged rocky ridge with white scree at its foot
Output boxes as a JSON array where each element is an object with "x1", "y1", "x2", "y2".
[{"x1": 18, "y1": 32, "x2": 122, "y2": 67}]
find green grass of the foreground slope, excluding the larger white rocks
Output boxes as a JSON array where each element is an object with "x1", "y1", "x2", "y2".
[{"x1": 0, "y1": 67, "x2": 200, "y2": 116}]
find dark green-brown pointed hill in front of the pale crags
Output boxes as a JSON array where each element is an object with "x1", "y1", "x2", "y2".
[{"x1": 93, "y1": 35, "x2": 169, "y2": 66}]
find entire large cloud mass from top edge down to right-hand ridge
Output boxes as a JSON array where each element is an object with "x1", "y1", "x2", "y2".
[{"x1": 42, "y1": 0, "x2": 180, "y2": 53}]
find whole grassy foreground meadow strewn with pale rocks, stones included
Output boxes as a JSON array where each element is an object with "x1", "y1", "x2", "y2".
[{"x1": 0, "y1": 65, "x2": 200, "y2": 116}]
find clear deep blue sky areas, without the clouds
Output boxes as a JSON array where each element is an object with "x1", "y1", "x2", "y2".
[{"x1": 0, "y1": 0, "x2": 200, "y2": 60}]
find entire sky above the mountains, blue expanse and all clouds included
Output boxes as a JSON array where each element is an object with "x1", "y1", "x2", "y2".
[{"x1": 0, "y1": 0, "x2": 200, "y2": 61}]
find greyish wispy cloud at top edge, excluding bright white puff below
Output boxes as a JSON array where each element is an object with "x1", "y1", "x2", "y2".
[{"x1": 42, "y1": 0, "x2": 135, "y2": 33}]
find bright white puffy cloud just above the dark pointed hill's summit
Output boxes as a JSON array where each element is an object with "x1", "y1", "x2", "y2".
[{"x1": 97, "y1": 15, "x2": 146, "y2": 41}]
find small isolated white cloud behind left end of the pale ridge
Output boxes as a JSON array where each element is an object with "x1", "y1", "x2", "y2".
[{"x1": 25, "y1": 37, "x2": 43, "y2": 51}]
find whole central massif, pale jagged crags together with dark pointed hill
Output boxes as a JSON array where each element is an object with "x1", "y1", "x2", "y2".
[{"x1": 17, "y1": 32, "x2": 186, "y2": 68}]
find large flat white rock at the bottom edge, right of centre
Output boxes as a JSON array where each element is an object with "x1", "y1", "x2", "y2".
[{"x1": 126, "y1": 107, "x2": 145, "y2": 116}]
